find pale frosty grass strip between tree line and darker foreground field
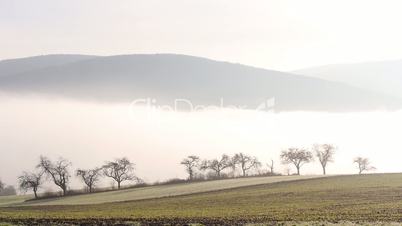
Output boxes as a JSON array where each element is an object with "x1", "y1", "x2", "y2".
[{"x1": 0, "y1": 176, "x2": 320, "y2": 206}]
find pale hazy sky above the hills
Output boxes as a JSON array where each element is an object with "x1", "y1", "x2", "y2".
[{"x1": 0, "y1": 0, "x2": 402, "y2": 70}]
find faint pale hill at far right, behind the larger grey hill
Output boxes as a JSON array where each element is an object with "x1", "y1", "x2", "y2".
[{"x1": 293, "y1": 60, "x2": 402, "y2": 98}]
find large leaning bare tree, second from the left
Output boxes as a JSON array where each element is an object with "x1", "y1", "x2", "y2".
[{"x1": 37, "y1": 156, "x2": 71, "y2": 196}]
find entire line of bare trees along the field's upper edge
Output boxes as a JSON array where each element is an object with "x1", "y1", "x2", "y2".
[{"x1": 11, "y1": 144, "x2": 375, "y2": 198}]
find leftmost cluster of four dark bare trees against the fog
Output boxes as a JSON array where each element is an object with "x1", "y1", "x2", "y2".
[{"x1": 18, "y1": 156, "x2": 140, "y2": 198}]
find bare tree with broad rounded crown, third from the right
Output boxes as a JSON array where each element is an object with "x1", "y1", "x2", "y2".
[{"x1": 281, "y1": 148, "x2": 313, "y2": 175}]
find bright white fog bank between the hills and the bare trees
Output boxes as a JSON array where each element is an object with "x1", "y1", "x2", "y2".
[{"x1": 0, "y1": 94, "x2": 402, "y2": 188}]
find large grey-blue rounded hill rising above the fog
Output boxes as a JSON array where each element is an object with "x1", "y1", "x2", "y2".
[{"x1": 0, "y1": 54, "x2": 402, "y2": 112}]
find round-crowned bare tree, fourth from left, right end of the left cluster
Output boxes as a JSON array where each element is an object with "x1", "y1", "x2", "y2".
[{"x1": 102, "y1": 157, "x2": 139, "y2": 189}]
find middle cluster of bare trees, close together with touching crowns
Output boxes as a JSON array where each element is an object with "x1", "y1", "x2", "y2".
[{"x1": 180, "y1": 153, "x2": 261, "y2": 180}]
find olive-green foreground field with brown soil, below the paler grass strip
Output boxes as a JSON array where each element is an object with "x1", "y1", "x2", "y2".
[{"x1": 0, "y1": 174, "x2": 402, "y2": 225}]
